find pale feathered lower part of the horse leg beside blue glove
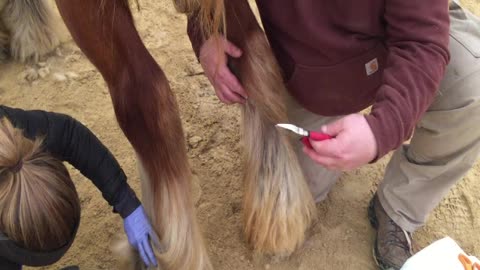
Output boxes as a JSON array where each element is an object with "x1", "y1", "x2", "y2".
[{"x1": 139, "y1": 156, "x2": 212, "y2": 270}]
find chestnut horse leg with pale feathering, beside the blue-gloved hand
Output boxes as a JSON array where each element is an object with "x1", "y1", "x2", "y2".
[{"x1": 57, "y1": 0, "x2": 211, "y2": 270}]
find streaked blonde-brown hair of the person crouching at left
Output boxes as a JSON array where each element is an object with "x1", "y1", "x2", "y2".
[{"x1": 0, "y1": 118, "x2": 80, "y2": 251}]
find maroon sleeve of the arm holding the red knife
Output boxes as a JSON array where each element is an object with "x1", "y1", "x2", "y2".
[{"x1": 367, "y1": 0, "x2": 450, "y2": 158}]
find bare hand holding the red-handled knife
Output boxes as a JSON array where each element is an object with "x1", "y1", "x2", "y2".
[{"x1": 303, "y1": 114, "x2": 377, "y2": 171}]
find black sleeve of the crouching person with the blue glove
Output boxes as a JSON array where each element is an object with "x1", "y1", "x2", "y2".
[{"x1": 0, "y1": 106, "x2": 140, "y2": 218}]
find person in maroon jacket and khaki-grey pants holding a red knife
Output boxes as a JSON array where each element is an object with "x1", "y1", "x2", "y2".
[{"x1": 188, "y1": 0, "x2": 480, "y2": 269}]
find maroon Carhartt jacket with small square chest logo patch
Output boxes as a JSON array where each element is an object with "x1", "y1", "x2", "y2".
[{"x1": 188, "y1": 0, "x2": 449, "y2": 158}]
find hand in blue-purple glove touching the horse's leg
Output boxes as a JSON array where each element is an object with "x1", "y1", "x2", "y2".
[{"x1": 123, "y1": 206, "x2": 158, "y2": 267}]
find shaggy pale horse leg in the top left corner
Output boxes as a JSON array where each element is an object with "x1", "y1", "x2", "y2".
[{"x1": 2, "y1": 0, "x2": 60, "y2": 62}]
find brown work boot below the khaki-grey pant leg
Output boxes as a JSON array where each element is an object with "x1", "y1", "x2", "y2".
[{"x1": 368, "y1": 194, "x2": 413, "y2": 270}]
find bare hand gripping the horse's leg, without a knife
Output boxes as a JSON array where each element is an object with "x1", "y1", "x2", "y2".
[{"x1": 200, "y1": 37, "x2": 247, "y2": 104}]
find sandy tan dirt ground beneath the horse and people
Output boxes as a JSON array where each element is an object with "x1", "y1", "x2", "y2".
[{"x1": 0, "y1": 0, "x2": 480, "y2": 270}]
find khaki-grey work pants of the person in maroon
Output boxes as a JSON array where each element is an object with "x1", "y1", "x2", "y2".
[{"x1": 288, "y1": 3, "x2": 480, "y2": 232}]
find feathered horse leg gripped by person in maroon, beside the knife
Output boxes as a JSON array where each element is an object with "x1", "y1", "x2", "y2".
[{"x1": 225, "y1": 0, "x2": 315, "y2": 256}]
